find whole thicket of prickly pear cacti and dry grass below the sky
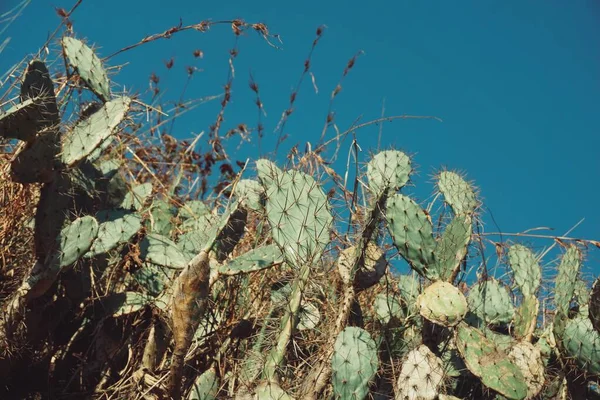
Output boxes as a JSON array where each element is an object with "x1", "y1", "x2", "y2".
[{"x1": 0, "y1": 20, "x2": 600, "y2": 400}]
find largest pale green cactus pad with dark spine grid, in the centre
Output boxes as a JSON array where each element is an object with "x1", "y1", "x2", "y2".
[{"x1": 258, "y1": 168, "x2": 333, "y2": 266}]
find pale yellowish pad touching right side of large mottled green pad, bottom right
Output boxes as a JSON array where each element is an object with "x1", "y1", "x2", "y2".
[{"x1": 508, "y1": 342, "x2": 545, "y2": 399}]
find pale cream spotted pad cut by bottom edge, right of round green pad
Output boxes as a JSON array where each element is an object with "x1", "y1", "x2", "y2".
[{"x1": 396, "y1": 345, "x2": 445, "y2": 400}]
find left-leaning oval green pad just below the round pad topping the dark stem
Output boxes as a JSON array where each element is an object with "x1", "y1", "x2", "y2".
[{"x1": 386, "y1": 194, "x2": 439, "y2": 280}]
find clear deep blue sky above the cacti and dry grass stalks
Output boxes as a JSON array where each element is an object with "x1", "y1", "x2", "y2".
[{"x1": 0, "y1": 0, "x2": 600, "y2": 274}]
